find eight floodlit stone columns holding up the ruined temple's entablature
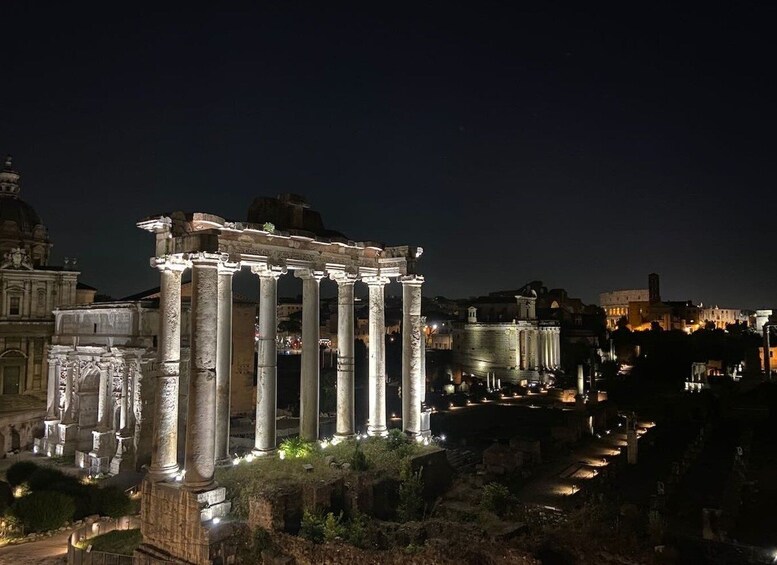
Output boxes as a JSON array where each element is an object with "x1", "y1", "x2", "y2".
[{"x1": 149, "y1": 253, "x2": 429, "y2": 490}]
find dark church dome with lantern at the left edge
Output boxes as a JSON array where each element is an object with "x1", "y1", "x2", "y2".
[{"x1": 0, "y1": 155, "x2": 51, "y2": 267}]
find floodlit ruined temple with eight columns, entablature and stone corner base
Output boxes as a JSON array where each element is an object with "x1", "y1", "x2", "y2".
[{"x1": 135, "y1": 212, "x2": 430, "y2": 563}]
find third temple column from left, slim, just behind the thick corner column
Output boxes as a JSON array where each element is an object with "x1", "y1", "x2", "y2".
[{"x1": 215, "y1": 261, "x2": 239, "y2": 464}]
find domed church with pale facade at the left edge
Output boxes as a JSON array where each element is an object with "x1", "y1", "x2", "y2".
[{"x1": 0, "y1": 156, "x2": 95, "y2": 456}]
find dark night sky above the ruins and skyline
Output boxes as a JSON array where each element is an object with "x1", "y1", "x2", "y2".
[{"x1": 0, "y1": 1, "x2": 777, "y2": 308}]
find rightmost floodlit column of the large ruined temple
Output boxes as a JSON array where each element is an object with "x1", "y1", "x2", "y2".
[{"x1": 400, "y1": 275, "x2": 424, "y2": 436}]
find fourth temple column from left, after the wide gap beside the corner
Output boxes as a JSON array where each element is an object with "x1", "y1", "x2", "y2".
[{"x1": 252, "y1": 268, "x2": 284, "y2": 455}]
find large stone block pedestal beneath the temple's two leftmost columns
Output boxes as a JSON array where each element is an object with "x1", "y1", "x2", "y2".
[{"x1": 133, "y1": 480, "x2": 234, "y2": 565}]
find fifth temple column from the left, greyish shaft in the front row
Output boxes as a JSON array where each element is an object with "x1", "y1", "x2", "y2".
[{"x1": 296, "y1": 270, "x2": 324, "y2": 441}]
